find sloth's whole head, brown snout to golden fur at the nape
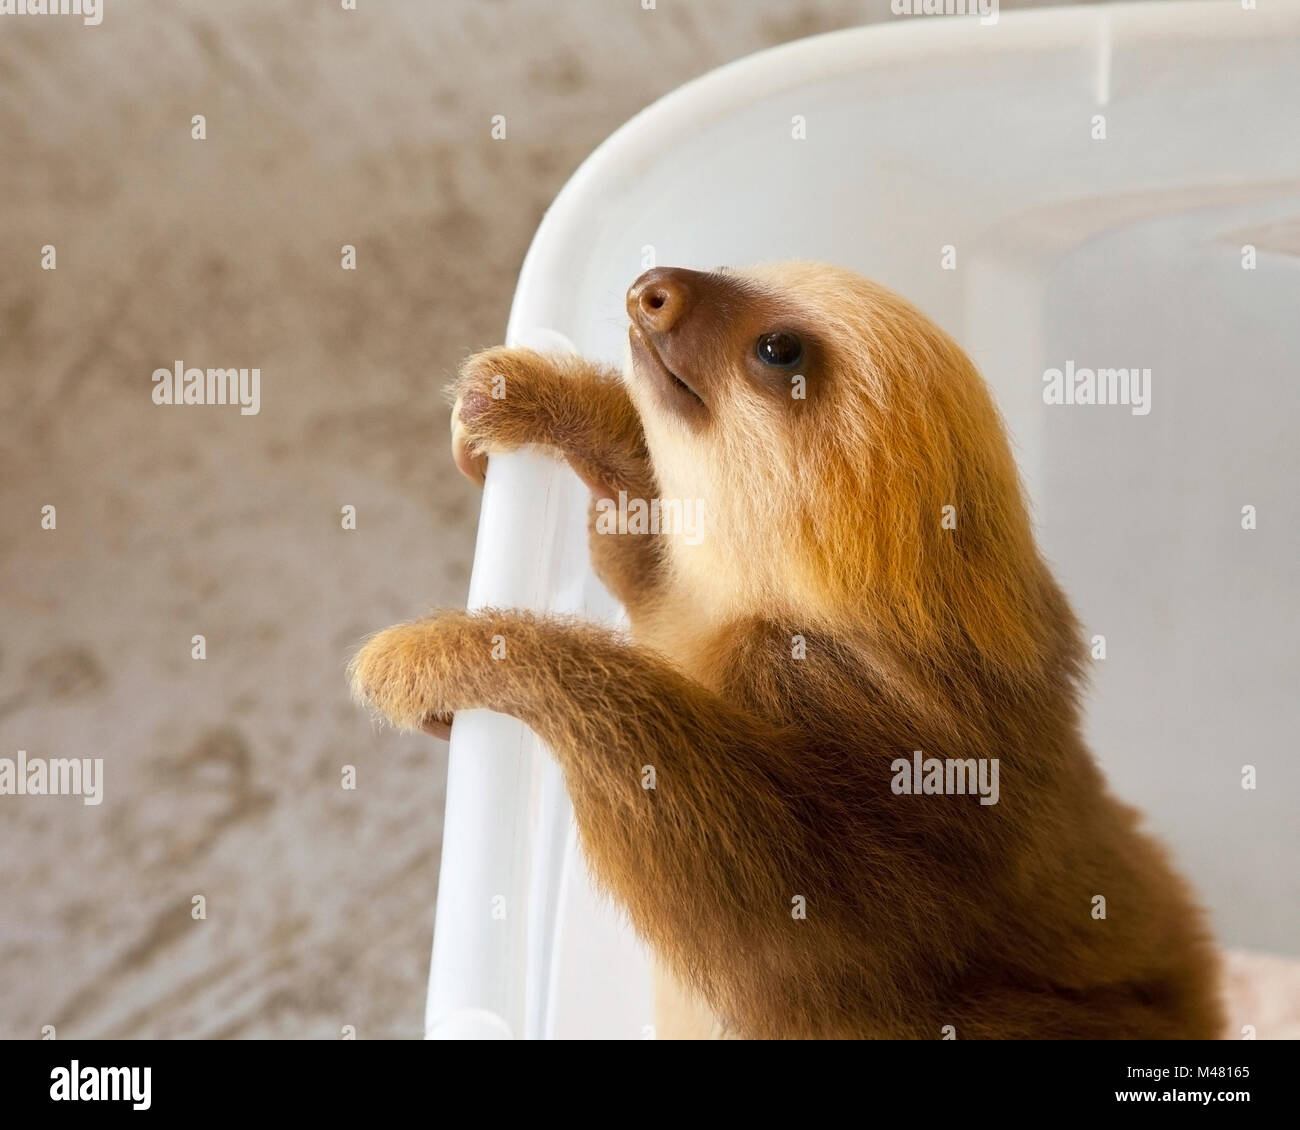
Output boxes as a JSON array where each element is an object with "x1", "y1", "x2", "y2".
[{"x1": 627, "y1": 263, "x2": 1069, "y2": 668}]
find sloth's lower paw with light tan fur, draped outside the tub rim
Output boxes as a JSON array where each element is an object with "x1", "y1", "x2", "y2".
[{"x1": 348, "y1": 616, "x2": 454, "y2": 736}]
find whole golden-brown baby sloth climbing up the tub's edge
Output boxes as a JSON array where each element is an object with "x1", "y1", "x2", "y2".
[{"x1": 352, "y1": 263, "x2": 1221, "y2": 1039}]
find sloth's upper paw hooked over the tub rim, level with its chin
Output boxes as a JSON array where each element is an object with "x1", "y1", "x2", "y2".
[{"x1": 450, "y1": 346, "x2": 546, "y2": 486}]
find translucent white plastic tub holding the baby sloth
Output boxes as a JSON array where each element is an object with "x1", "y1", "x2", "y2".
[{"x1": 426, "y1": 0, "x2": 1300, "y2": 1038}]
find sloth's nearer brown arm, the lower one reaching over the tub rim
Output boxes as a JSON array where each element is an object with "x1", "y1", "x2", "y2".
[{"x1": 351, "y1": 610, "x2": 811, "y2": 954}]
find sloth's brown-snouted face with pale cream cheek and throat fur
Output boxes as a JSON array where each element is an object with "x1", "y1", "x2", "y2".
[{"x1": 625, "y1": 264, "x2": 861, "y2": 606}]
